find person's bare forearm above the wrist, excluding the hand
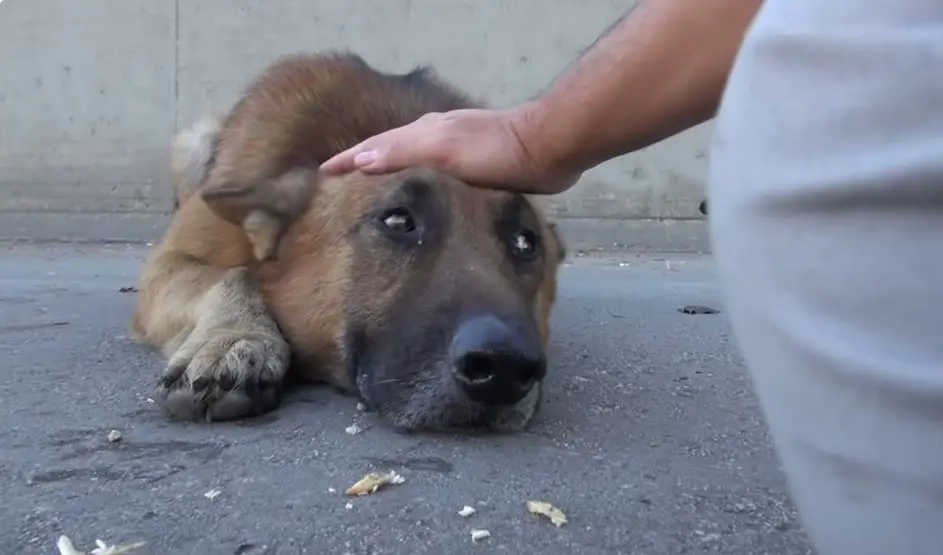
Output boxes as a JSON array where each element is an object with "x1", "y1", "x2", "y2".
[{"x1": 516, "y1": 0, "x2": 762, "y2": 176}]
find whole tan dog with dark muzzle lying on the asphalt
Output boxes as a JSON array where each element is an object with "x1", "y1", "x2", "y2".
[{"x1": 132, "y1": 53, "x2": 564, "y2": 431}]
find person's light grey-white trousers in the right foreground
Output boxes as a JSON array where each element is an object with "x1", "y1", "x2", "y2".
[{"x1": 709, "y1": 0, "x2": 943, "y2": 555}]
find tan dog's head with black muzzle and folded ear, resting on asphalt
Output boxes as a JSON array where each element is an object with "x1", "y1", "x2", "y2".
[{"x1": 203, "y1": 169, "x2": 564, "y2": 431}]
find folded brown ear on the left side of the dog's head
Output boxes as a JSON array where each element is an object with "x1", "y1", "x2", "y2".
[{"x1": 200, "y1": 168, "x2": 321, "y2": 262}]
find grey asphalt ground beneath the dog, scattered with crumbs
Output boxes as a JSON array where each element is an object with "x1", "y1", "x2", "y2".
[{"x1": 0, "y1": 244, "x2": 811, "y2": 555}]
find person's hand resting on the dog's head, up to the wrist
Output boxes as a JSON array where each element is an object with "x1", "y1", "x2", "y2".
[{"x1": 321, "y1": 108, "x2": 579, "y2": 194}]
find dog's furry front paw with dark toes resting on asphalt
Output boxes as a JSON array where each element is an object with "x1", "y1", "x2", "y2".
[{"x1": 155, "y1": 333, "x2": 289, "y2": 422}]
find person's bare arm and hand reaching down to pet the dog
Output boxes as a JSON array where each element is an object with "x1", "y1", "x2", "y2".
[{"x1": 322, "y1": 0, "x2": 761, "y2": 193}]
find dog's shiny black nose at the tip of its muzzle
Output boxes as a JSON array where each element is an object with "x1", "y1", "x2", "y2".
[{"x1": 451, "y1": 316, "x2": 547, "y2": 405}]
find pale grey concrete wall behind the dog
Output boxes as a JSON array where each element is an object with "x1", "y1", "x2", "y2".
[{"x1": 0, "y1": 0, "x2": 708, "y2": 250}]
